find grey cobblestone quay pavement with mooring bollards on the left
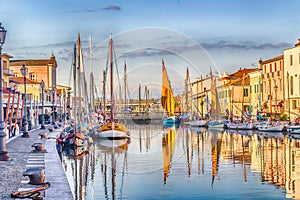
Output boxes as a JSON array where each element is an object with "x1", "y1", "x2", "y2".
[{"x1": 0, "y1": 124, "x2": 73, "y2": 199}]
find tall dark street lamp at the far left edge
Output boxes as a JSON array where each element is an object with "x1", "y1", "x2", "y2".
[{"x1": 0, "y1": 23, "x2": 10, "y2": 161}]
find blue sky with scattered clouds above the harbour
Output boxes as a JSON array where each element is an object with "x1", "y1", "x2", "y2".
[{"x1": 0, "y1": 0, "x2": 300, "y2": 98}]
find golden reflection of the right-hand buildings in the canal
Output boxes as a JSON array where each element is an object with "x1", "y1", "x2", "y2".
[{"x1": 221, "y1": 132, "x2": 300, "y2": 199}]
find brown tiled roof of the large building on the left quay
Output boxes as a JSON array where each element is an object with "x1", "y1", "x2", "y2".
[{"x1": 9, "y1": 54, "x2": 57, "y2": 67}]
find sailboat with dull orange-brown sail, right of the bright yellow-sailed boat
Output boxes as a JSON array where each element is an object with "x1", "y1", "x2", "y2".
[{"x1": 207, "y1": 69, "x2": 224, "y2": 129}]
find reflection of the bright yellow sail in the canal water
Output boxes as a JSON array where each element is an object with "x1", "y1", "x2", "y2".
[{"x1": 162, "y1": 129, "x2": 175, "y2": 184}]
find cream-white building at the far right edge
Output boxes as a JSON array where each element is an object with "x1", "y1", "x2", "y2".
[{"x1": 283, "y1": 39, "x2": 300, "y2": 120}]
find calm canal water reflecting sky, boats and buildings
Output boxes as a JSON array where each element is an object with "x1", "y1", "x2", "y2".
[{"x1": 61, "y1": 125, "x2": 300, "y2": 200}]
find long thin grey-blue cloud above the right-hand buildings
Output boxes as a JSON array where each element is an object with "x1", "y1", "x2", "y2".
[{"x1": 201, "y1": 40, "x2": 292, "y2": 49}]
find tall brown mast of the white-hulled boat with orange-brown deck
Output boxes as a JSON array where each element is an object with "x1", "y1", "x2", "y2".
[{"x1": 109, "y1": 33, "x2": 114, "y2": 122}]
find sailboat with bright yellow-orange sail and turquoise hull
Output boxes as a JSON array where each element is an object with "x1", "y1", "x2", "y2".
[{"x1": 161, "y1": 60, "x2": 178, "y2": 126}]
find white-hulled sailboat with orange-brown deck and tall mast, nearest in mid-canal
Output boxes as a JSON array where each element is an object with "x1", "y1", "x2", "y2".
[{"x1": 95, "y1": 34, "x2": 129, "y2": 139}]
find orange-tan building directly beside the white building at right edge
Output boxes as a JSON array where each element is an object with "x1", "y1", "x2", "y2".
[{"x1": 259, "y1": 55, "x2": 285, "y2": 117}]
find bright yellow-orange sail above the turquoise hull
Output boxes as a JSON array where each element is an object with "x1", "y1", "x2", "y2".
[{"x1": 161, "y1": 60, "x2": 175, "y2": 116}]
